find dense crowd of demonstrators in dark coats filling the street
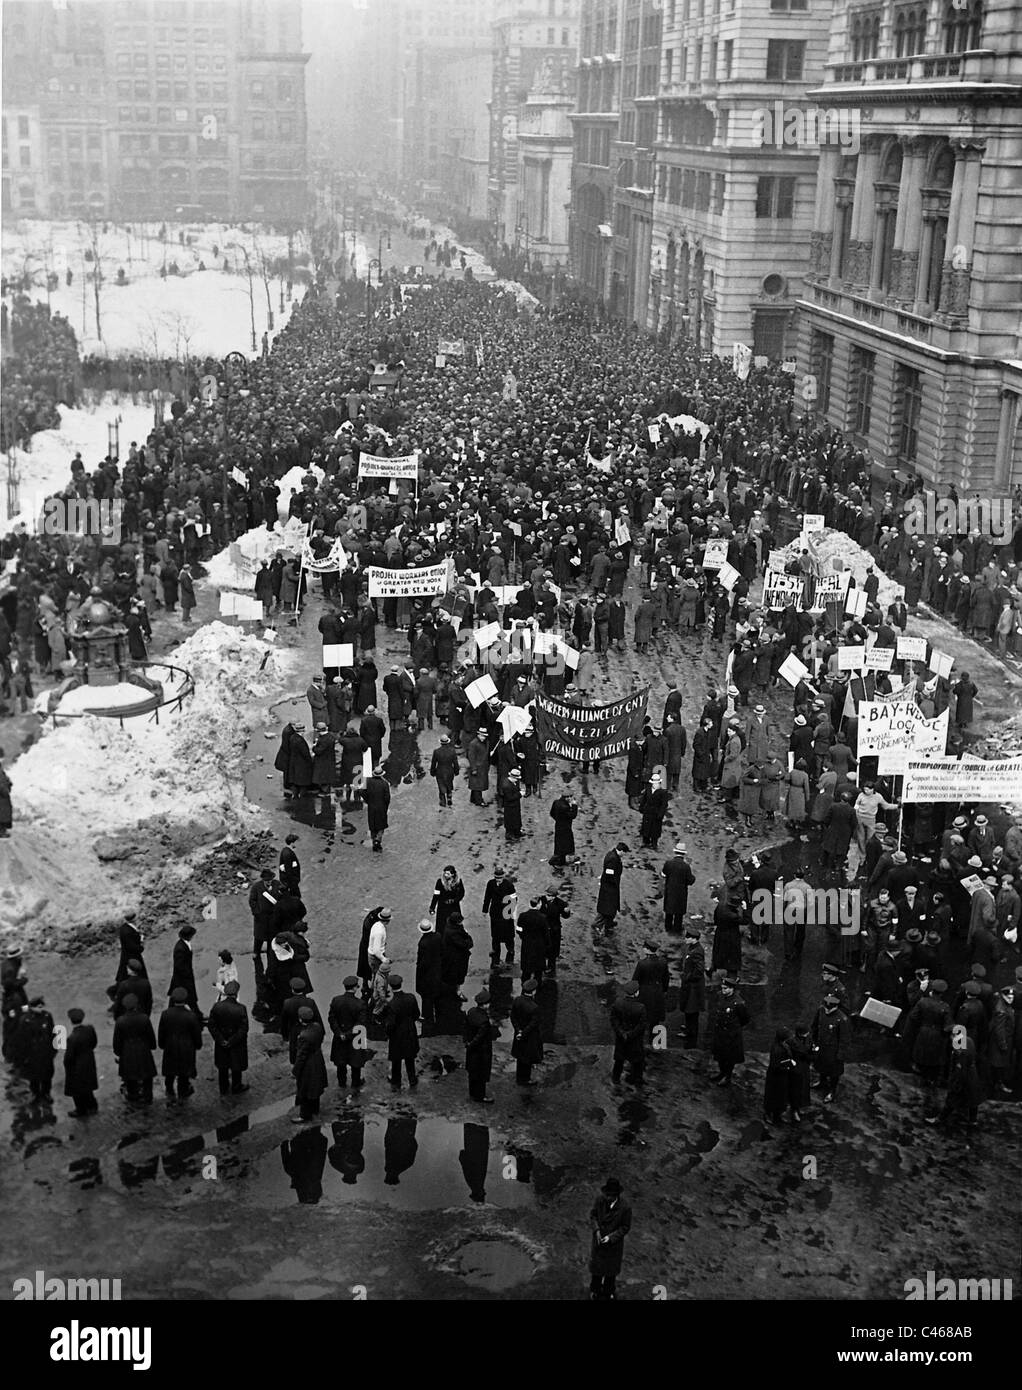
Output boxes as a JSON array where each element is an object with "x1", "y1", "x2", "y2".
[{"x1": 3, "y1": 211, "x2": 1022, "y2": 1295}]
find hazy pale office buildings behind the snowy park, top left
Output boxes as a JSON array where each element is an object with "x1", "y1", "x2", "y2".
[{"x1": 3, "y1": 0, "x2": 307, "y2": 221}]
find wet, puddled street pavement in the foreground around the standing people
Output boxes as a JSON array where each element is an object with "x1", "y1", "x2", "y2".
[{"x1": 0, "y1": 567, "x2": 1019, "y2": 1298}]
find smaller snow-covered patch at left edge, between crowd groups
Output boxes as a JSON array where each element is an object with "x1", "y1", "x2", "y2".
[{"x1": 0, "y1": 396, "x2": 161, "y2": 535}]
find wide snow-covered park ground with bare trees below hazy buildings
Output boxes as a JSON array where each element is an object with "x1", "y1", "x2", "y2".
[{"x1": 3, "y1": 221, "x2": 306, "y2": 359}]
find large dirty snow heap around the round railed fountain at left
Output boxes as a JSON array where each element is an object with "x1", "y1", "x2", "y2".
[{"x1": 0, "y1": 623, "x2": 291, "y2": 931}]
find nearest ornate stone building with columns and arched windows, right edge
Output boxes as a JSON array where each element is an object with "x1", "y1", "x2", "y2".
[{"x1": 798, "y1": 0, "x2": 1022, "y2": 495}]
